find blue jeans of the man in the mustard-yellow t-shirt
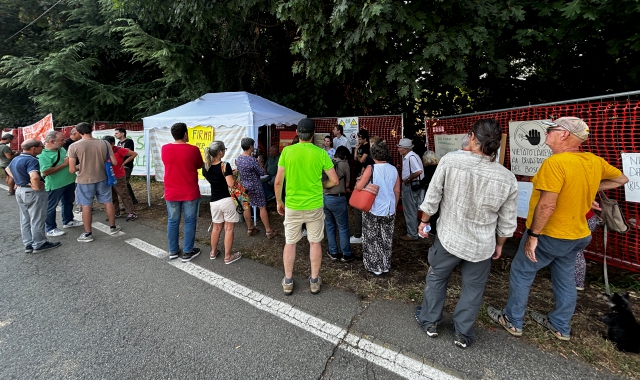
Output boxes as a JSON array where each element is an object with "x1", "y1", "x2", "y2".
[{"x1": 504, "y1": 233, "x2": 591, "y2": 335}]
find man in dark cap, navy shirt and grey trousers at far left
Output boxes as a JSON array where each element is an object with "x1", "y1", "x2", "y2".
[{"x1": 7, "y1": 139, "x2": 60, "y2": 253}]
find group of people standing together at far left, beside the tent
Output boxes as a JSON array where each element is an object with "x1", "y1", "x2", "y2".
[{"x1": 1, "y1": 123, "x2": 137, "y2": 253}]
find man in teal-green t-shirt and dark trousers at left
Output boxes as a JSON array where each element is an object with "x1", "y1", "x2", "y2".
[{"x1": 38, "y1": 131, "x2": 82, "y2": 236}]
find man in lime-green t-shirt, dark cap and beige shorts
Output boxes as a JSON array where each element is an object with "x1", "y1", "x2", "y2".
[{"x1": 274, "y1": 118, "x2": 338, "y2": 295}]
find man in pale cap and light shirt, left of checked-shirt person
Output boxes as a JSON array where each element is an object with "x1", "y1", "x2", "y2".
[{"x1": 398, "y1": 139, "x2": 424, "y2": 241}]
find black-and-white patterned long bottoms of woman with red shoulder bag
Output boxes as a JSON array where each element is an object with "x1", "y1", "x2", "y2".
[{"x1": 362, "y1": 212, "x2": 395, "y2": 272}]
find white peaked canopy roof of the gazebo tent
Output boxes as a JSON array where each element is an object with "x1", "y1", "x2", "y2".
[{"x1": 142, "y1": 91, "x2": 306, "y2": 134}]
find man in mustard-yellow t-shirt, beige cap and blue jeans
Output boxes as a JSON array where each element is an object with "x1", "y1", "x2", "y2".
[{"x1": 487, "y1": 117, "x2": 629, "y2": 340}]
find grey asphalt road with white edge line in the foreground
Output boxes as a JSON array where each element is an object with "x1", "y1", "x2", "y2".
[{"x1": 0, "y1": 186, "x2": 618, "y2": 379}]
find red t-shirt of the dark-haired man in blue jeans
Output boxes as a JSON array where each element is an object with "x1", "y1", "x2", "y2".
[{"x1": 162, "y1": 143, "x2": 204, "y2": 202}]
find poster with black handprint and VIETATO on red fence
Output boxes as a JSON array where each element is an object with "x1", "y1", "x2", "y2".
[{"x1": 509, "y1": 120, "x2": 553, "y2": 176}]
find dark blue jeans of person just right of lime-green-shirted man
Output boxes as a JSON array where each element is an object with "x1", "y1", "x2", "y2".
[{"x1": 323, "y1": 195, "x2": 351, "y2": 257}]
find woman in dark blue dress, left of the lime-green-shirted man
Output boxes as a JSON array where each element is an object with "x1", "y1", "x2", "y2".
[{"x1": 236, "y1": 137, "x2": 278, "y2": 239}]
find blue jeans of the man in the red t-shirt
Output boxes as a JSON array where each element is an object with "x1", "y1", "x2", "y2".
[{"x1": 167, "y1": 198, "x2": 200, "y2": 253}]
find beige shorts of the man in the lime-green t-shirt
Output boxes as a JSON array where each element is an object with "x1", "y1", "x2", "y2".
[{"x1": 283, "y1": 207, "x2": 324, "y2": 244}]
